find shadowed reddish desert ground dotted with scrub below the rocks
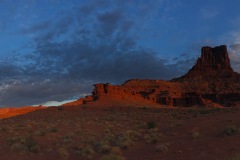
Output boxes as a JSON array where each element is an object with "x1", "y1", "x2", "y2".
[{"x1": 0, "y1": 105, "x2": 240, "y2": 160}]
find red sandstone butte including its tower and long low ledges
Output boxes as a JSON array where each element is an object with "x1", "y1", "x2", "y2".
[{"x1": 63, "y1": 45, "x2": 240, "y2": 107}]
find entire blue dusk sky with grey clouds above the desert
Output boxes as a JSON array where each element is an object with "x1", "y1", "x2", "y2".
[{"x1": 0, "y1": 0, "x2": 240, "y2": 107}]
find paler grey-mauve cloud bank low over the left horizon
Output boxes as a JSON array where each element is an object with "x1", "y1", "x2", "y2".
[{"x1": 0, "y1": 78, "x2": 92, "y2": 107}]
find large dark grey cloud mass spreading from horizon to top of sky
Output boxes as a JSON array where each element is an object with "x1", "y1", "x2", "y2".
[{"x1": 0, "y1": 0, "x2": 192, "y2": 106}]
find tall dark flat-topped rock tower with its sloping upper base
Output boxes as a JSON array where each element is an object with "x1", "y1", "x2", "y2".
[{"x1": 171, "y1": 45, "x2": 240, "y2": 83}]
